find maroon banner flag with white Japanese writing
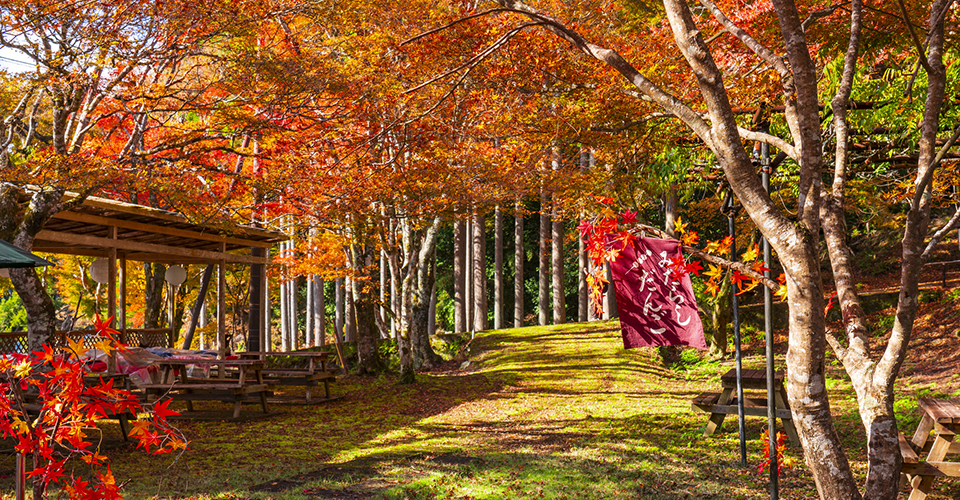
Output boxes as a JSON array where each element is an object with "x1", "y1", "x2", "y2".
[{"x1": 611, "y1": 238, "x2": 707, "y2": 349}]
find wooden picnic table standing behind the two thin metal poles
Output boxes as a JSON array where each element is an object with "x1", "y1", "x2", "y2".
[{"x1": 690, "y1": 368, "x2": 800, "y2": 446}]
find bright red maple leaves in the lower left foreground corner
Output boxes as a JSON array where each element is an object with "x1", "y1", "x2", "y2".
[{"x1": 0, "y1": 317, "x2": 187, "y2": 499}]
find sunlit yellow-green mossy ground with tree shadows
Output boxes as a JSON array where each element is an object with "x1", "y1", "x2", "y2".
[{"x1": 0, "y1": 312, "x2": 960, "y2": 500}]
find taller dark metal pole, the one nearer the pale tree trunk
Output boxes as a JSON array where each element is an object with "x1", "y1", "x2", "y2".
[{"x1": 760, "y1": 143, "x2": 780, "y2": 500}]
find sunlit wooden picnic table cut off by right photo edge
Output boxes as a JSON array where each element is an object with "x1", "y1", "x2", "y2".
[{"x1": 900, "y1": 398, "x2": 960, "y2": 500}]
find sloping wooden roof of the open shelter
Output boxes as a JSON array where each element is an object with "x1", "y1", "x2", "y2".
[{"x1": 33, "y1": 194, "x2": 288, "y2": 264}]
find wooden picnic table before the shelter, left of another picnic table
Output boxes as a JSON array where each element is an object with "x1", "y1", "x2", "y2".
[{"x1": 140, "y1": 358, "x2": 268, "y2": 420}]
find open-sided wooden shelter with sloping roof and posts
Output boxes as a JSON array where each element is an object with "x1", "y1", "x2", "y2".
[{"x1": 3, "y1": 194, "x2": 287, "y2": 356}]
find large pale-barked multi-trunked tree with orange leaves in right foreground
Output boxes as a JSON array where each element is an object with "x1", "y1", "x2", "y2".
[{"x1": 414, "y1": 0, "x2": 960, "y2": 498}]
